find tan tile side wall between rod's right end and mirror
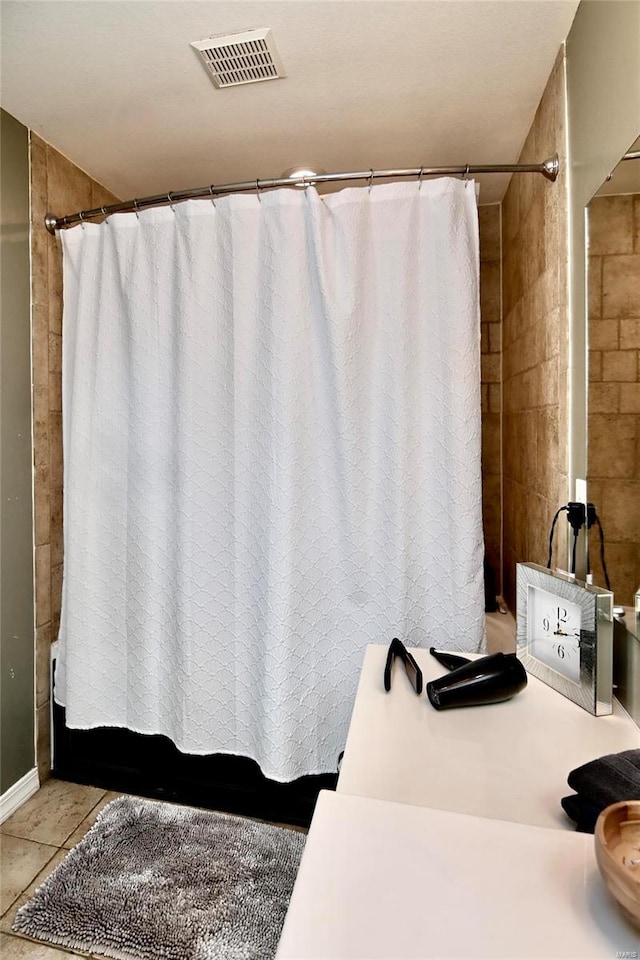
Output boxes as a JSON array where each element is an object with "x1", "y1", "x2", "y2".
[{"x1": 502, "y1": 52, "x2": 569, "y2": 610}]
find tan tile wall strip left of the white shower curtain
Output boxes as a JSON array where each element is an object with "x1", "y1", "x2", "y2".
[{"x1": 31, "y1": 133, "x2": 118, "y2": 780}]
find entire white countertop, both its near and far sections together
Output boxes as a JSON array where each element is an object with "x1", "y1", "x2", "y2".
[{"x1": 276, "y1": 645, "x2": 640, "y2": 960}]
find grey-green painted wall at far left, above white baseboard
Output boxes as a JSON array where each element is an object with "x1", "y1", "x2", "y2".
[{"x1": 0, "y1": 110, "x2": 35, "y2": 793}]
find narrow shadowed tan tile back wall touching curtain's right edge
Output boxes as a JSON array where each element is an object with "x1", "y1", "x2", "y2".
[{"x1": 478, "y1": 204, "x2": 502, "y2": 593}]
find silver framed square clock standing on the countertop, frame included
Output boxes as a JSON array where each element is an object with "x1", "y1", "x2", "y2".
[{"x1": 516, "y1": 563, "x2": 613, "y2": 717}]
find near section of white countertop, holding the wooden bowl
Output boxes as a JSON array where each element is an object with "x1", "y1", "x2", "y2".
[{"x1": 276, "y1": 791, "x2": 640, "y2": 960}]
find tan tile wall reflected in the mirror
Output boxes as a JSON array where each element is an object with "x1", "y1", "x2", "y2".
[{"x1": 587, "y1": 194, "x2": 640, "y2": 605}]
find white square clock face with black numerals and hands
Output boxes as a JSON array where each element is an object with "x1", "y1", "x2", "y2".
[{"x1": 527, "y1": 584, "x2": 582, "y2": 683}]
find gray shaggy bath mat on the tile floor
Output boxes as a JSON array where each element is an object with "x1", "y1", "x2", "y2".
[{"x1": 13, "y1": 797, "x2": 305, "y2": 960}]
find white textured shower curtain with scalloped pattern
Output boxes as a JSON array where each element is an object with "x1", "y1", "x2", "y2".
[{"x1": 55, "y1": 179, "x2": 484, "y2": 780}]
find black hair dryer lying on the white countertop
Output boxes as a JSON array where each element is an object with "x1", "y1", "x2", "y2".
[{"x1": 427, "y1": 647, "x2": 527, "y2": 710}]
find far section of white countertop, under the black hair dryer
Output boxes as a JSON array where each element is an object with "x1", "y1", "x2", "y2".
[{"x1": 337, "y1": 645, "x2": 640, "y2": 829}]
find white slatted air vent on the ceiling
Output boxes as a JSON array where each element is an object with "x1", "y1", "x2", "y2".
[{"x1": 191, "y1": 27, "x2": 286, "y2": 87}]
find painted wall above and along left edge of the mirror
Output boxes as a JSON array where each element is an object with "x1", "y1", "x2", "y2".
[{"x1": 567, "y1": 0, "x2": 640, "y2": 506}]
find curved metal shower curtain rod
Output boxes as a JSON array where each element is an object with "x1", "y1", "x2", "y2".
[{"x1": 44, "y1": 154, "x2": 560, "y2": 233}]
